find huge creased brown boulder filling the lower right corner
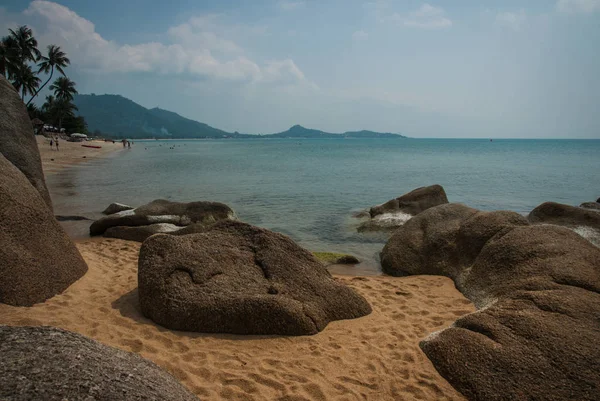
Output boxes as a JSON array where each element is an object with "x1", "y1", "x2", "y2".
[{"x1": 421, "y1": 226, "x2": 600, "y2": 401}]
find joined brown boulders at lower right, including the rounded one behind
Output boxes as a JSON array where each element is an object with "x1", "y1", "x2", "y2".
[{"x1": 382, "y1": 205, "x2": 600, "y2": 401}]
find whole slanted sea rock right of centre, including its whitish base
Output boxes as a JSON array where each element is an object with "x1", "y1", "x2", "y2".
[{"x1": 358, "y1": 185, "x2": 448, "y2": 232}]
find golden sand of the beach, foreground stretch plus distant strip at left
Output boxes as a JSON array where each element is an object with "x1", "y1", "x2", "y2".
[{"x1": 0, "y1": 140, "x2": 475, "y2": 401}]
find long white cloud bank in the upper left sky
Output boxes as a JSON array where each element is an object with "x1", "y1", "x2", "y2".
[{"x1": 11, "y1": 0, "x2": 313, "y2": 85}]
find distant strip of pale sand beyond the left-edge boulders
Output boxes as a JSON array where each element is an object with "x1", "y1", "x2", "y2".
[{"x1": 35, "y1": 135, "x2": 123, "y2": 175}]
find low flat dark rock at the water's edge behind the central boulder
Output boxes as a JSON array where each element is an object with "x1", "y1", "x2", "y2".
[{"x1": 90, "y1": 199, "x2": 235, "y2": 236}]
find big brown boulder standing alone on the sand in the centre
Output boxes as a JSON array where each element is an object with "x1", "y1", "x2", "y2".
[{"x1": 138, "y1": 221, "x2": 371, "y2": 335}]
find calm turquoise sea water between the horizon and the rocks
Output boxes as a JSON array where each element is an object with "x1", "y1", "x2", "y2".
[{"x1": 48, "y1": 139, "x2": 600, "y2": 273}]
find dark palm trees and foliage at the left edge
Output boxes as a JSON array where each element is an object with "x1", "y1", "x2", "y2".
[{"x1": 0, "y1": 25, "x2": 87, "y2": 133}]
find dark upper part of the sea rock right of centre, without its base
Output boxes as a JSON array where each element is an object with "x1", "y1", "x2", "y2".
[{"x1": 370, "y1": 185, "x2": 448, "y2": 217}]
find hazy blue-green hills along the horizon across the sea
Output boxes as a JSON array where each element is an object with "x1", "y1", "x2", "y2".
[{"x1": 74, "y1": 94, "x2": 406, "y2": 139}]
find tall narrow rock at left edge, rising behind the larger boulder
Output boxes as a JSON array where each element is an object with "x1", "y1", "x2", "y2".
[{"x1": 0, "y1": 76, "x2": 52, "y2": 208}]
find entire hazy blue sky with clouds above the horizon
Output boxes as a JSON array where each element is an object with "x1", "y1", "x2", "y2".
[{"x1": 0, "y1": 0, "x2": 600, "y2": 138}]
